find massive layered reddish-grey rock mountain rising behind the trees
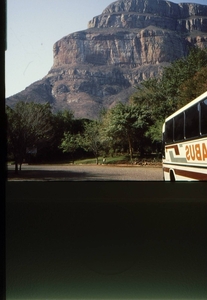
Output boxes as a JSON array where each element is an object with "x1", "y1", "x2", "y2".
[{"x1": 7, "y1": 0, "x2": 207, "y2": 119}]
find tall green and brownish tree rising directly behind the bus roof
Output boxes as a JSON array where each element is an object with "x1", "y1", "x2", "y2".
[{"x1": 130, "y1": 48, "x2": 207, "y2": 155}]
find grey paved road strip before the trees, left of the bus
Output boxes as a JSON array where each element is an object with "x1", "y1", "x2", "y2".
[{"x1": 8, "y1": 165, "x2": 163, "y2": 181}]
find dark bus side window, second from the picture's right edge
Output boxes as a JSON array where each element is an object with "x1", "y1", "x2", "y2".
[{"x1": 185, "y1": 104, "x2": 200, "y2": 138}]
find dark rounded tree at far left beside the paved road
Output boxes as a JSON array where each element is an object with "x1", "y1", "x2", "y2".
[{"x1": 6, "y1": 102, "x2": 52, "y2": 173}]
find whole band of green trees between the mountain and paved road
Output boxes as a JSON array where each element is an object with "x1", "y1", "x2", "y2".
[{"x1": 6, "y1": 48, "x2": 207, "y2": 172}]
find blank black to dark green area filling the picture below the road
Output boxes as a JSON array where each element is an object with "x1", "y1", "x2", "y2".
[{"x1": 6, "y1": 182, "x2": 207, "y2": 300}]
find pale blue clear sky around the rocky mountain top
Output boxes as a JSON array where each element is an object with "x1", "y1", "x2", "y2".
[{"x1": 5, "y1": 0, "x2": 207, "y2": 97}]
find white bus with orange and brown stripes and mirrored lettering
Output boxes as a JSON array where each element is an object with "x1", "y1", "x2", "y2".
[{"x1": 162, "y1": 92, "x2": 207, "y2": 182}]
